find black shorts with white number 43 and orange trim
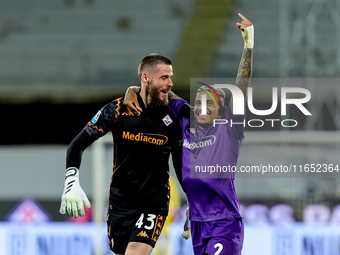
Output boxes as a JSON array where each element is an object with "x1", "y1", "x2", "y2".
[{"x1": 106, "y1": 212, "x2": 166, "y2": 254}]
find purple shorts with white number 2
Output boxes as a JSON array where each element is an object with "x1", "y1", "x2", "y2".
[{"x1": 191, "y1": 218, "x2": 244, "y2": 255}]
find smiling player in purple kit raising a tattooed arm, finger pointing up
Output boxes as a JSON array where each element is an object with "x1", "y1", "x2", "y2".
[{"x1": 126, "y1": 14, "x2": 254, "y2": 255}]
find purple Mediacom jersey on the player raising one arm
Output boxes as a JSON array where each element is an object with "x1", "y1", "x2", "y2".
[{"x1": 170, "y1": 99, "x2": 245, "y2": 222}]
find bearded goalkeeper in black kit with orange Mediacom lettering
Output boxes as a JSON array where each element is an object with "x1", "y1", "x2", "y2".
[{"x1": 60, "y1": 54, "x2": 181, "y2": 255}]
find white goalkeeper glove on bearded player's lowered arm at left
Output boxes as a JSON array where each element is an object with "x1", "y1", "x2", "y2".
[{"x1": 59, "y1": 167, "x2": 91, "y2": 218}]
